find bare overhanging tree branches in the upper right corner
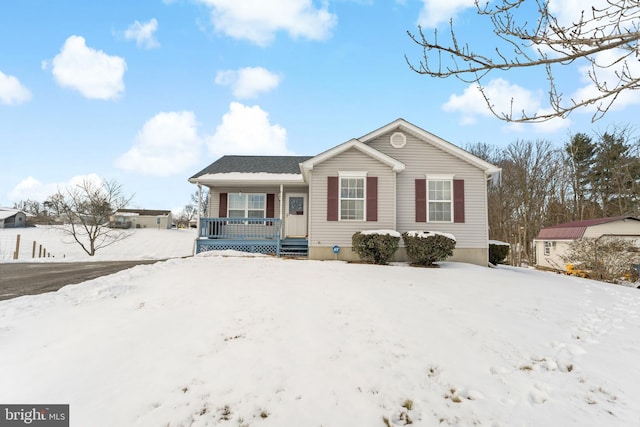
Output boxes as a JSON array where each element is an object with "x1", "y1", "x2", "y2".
[{"x1": 405, "y1": 0, "x2": 640, "y2": 123}]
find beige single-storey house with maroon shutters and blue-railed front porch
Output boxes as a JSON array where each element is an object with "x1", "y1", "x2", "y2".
[{"x1": 189, "y1": 119, "x2": 500, "y2": 266}]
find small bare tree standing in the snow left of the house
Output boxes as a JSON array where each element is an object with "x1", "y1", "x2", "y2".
[{"x1": 45, "y1": 179, "x2": 132, "y2": 256}]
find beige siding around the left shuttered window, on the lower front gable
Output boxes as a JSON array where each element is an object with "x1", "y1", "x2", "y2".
[{"x1": 309, "y1": 148, "x2": 395, "y2": 247}]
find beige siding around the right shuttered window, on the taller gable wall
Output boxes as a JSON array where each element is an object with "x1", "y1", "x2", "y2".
[{"x1": 369, "y1": 131, "x2": 489, "y2": 248}]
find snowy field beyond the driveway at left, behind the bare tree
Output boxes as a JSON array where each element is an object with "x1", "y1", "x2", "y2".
[{"x1": 0, "y1": 226, "x2": 197, "y2": 262}]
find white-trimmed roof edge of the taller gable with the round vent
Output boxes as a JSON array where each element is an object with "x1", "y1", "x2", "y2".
[{"x1": 358, "y1": 118, "x2": 502, "y2": 177}]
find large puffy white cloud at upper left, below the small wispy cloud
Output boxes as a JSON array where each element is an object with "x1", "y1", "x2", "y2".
[{"x1": 43, "y1": 36, "x2": 127, "y2": 99}]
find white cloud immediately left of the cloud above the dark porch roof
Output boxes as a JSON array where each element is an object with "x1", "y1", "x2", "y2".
[{"x1": 115, "y1": 111, "x2": 202, "y2": 176}]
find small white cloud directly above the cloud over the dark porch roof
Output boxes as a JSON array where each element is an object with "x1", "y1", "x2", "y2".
[{"x1": 215, "y1": 67, "x2": 282, "y2": 99}]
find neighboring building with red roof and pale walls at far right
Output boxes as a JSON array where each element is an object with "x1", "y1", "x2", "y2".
[{"x1": 533, "y1": 216, "x2": 640, "y2": 270}]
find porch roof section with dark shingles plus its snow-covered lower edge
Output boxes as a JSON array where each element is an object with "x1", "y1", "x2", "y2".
[{"x1": 189, "y1": 156, "x2": 311, "y2": 183}]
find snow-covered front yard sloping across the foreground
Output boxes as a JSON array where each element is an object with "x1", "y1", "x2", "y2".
[{"x1": 0, "y1": 232, "x2": 640, "y2": 427}]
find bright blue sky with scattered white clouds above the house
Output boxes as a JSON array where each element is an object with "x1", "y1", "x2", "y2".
[{"x1": 0, "y1": 0, "x2": 640, "y2": 210}]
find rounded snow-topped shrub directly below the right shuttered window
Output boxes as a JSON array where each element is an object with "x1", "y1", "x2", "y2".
[{"x1": 402, "y1": 231, "x2": 456, "y2": 267}]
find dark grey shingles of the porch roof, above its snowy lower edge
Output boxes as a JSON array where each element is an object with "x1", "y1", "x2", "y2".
[{"x1": 190, "y1": 156, "x2": 313, "y2": 179}]
